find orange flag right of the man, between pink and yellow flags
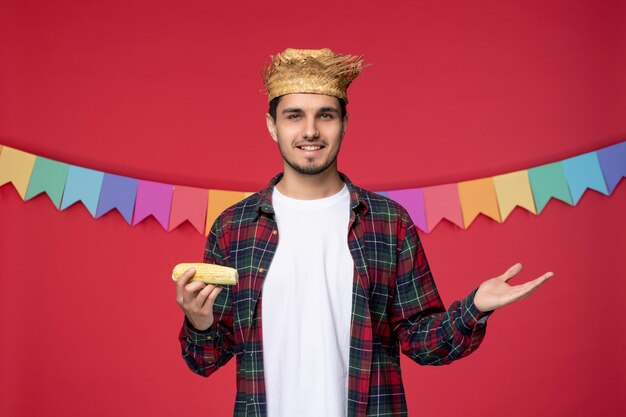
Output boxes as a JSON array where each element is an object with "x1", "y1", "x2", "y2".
[{"x1": 458, "y1": 177, "x2": 502, "y2": 229}]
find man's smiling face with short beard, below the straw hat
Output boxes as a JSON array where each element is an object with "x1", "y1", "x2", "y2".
[{"x1": 266, "y1": 94, "x2": 348, "y2": 175}]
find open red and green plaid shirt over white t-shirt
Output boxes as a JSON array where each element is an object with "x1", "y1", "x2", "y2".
[{"x1": 179, "y1": 173, "x2": 491, "y2": 417}]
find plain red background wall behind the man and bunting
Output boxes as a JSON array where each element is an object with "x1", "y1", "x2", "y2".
[{"x1": 0, "y1": 0, "x2": 626, "y2": 417}]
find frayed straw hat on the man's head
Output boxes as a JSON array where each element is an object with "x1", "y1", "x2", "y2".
[{"x1": 262, "y1": 48, "x2": 363, "y2": 103}]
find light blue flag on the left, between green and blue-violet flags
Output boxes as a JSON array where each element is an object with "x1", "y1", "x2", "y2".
[{"x1": 61, "y1": 165, "x2": 104, "y2": 217}]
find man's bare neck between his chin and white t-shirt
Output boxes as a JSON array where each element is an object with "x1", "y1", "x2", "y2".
[{"x1": 276, "y1": 164, "x2": 344, "y2": 200}]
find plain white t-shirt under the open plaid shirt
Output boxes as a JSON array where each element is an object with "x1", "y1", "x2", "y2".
[{"x1": 261, "y1": 184, "x2": 354, "y2": 417}]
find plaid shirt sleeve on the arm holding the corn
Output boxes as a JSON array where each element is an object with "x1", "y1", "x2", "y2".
[{"x1": 178, "y1": 216, "x2": 235, "y2": 377}]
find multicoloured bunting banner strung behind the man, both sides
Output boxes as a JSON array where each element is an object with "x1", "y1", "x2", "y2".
[{"x1": 0, "y1": 141, "x2": 626, "y2": 236}]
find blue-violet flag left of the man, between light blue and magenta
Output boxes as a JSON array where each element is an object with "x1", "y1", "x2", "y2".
[{"x1": 96, "y1": 173, "x2": 138, "y2": 224}]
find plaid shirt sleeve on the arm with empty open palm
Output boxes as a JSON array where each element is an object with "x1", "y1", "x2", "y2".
[{"x1": 391, "y1": 215, "x2": 493, "y2": 365}]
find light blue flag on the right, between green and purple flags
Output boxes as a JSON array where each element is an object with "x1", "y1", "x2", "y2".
[{"x1": 563, "y1": 152, "x2": 609, "y2": 204}]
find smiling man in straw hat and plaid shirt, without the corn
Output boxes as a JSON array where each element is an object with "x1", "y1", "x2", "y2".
[{"x1": 176, "y1": 49, "x2": 552, "y2": 417}]
